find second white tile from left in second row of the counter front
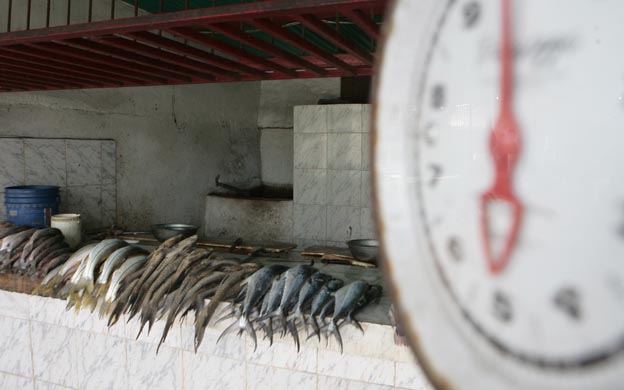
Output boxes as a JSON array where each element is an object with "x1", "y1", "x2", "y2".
[{"x1": 31, "y1": 322, "x2": 81, "y2": 387}]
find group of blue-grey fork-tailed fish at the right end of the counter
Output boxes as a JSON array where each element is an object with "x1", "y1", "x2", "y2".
[{"x1": 217, "y1": 265, "x2": 382, "y2": 351}]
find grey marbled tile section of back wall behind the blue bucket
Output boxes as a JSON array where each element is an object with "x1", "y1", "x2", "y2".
[{"x1": 0, "y1": 138, "x2": 117, "y2": 228}]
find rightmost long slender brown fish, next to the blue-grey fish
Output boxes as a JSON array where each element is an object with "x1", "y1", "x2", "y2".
[{"x1": 195, "y1": 264, "x2": 258, "y2": 352}]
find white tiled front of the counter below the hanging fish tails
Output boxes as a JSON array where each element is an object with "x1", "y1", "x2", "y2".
[{"x1": 0, "y1": 291, "x2": 431, "y2": 390}]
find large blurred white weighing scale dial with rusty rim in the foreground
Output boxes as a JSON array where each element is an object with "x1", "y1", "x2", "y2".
[{"x1": 374, "y1": 0, "x2": 624, "y2": 389}]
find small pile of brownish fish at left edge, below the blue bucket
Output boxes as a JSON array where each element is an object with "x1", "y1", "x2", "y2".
[{"x1": 0, "y1": 222, "x2": 72, "y2": 277}]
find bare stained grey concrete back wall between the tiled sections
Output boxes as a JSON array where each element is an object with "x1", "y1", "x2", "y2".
[{"x1": 0, "y1": 83, "x2": 260, "y2": 229}]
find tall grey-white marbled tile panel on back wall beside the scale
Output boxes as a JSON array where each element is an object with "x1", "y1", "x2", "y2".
[{"x1": 293, "y1": 104, "x2": 375, "y2": 247}]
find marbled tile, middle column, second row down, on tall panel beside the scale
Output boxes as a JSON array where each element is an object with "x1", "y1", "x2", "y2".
[{"x1": 327, "y1": 134, "x2": 362, "y2": 170}]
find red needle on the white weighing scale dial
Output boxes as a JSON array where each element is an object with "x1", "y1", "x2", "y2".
[{"x1": 481, "y1": 0, "x2": 522, "y2": 274}]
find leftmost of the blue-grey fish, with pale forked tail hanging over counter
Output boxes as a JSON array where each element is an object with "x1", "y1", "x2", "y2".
[{"x1": 217, "y1": 264, "x2": 288, "y2": 351}]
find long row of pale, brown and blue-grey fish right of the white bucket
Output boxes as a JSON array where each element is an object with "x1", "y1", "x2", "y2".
[{"x1": 36, "y1": 236, "x2": 382, "y2": 349}]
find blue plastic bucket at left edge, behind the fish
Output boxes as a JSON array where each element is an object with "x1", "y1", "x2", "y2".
[{"x1": 4, "y1": 186, "x2": 61, "y2": 227}]
